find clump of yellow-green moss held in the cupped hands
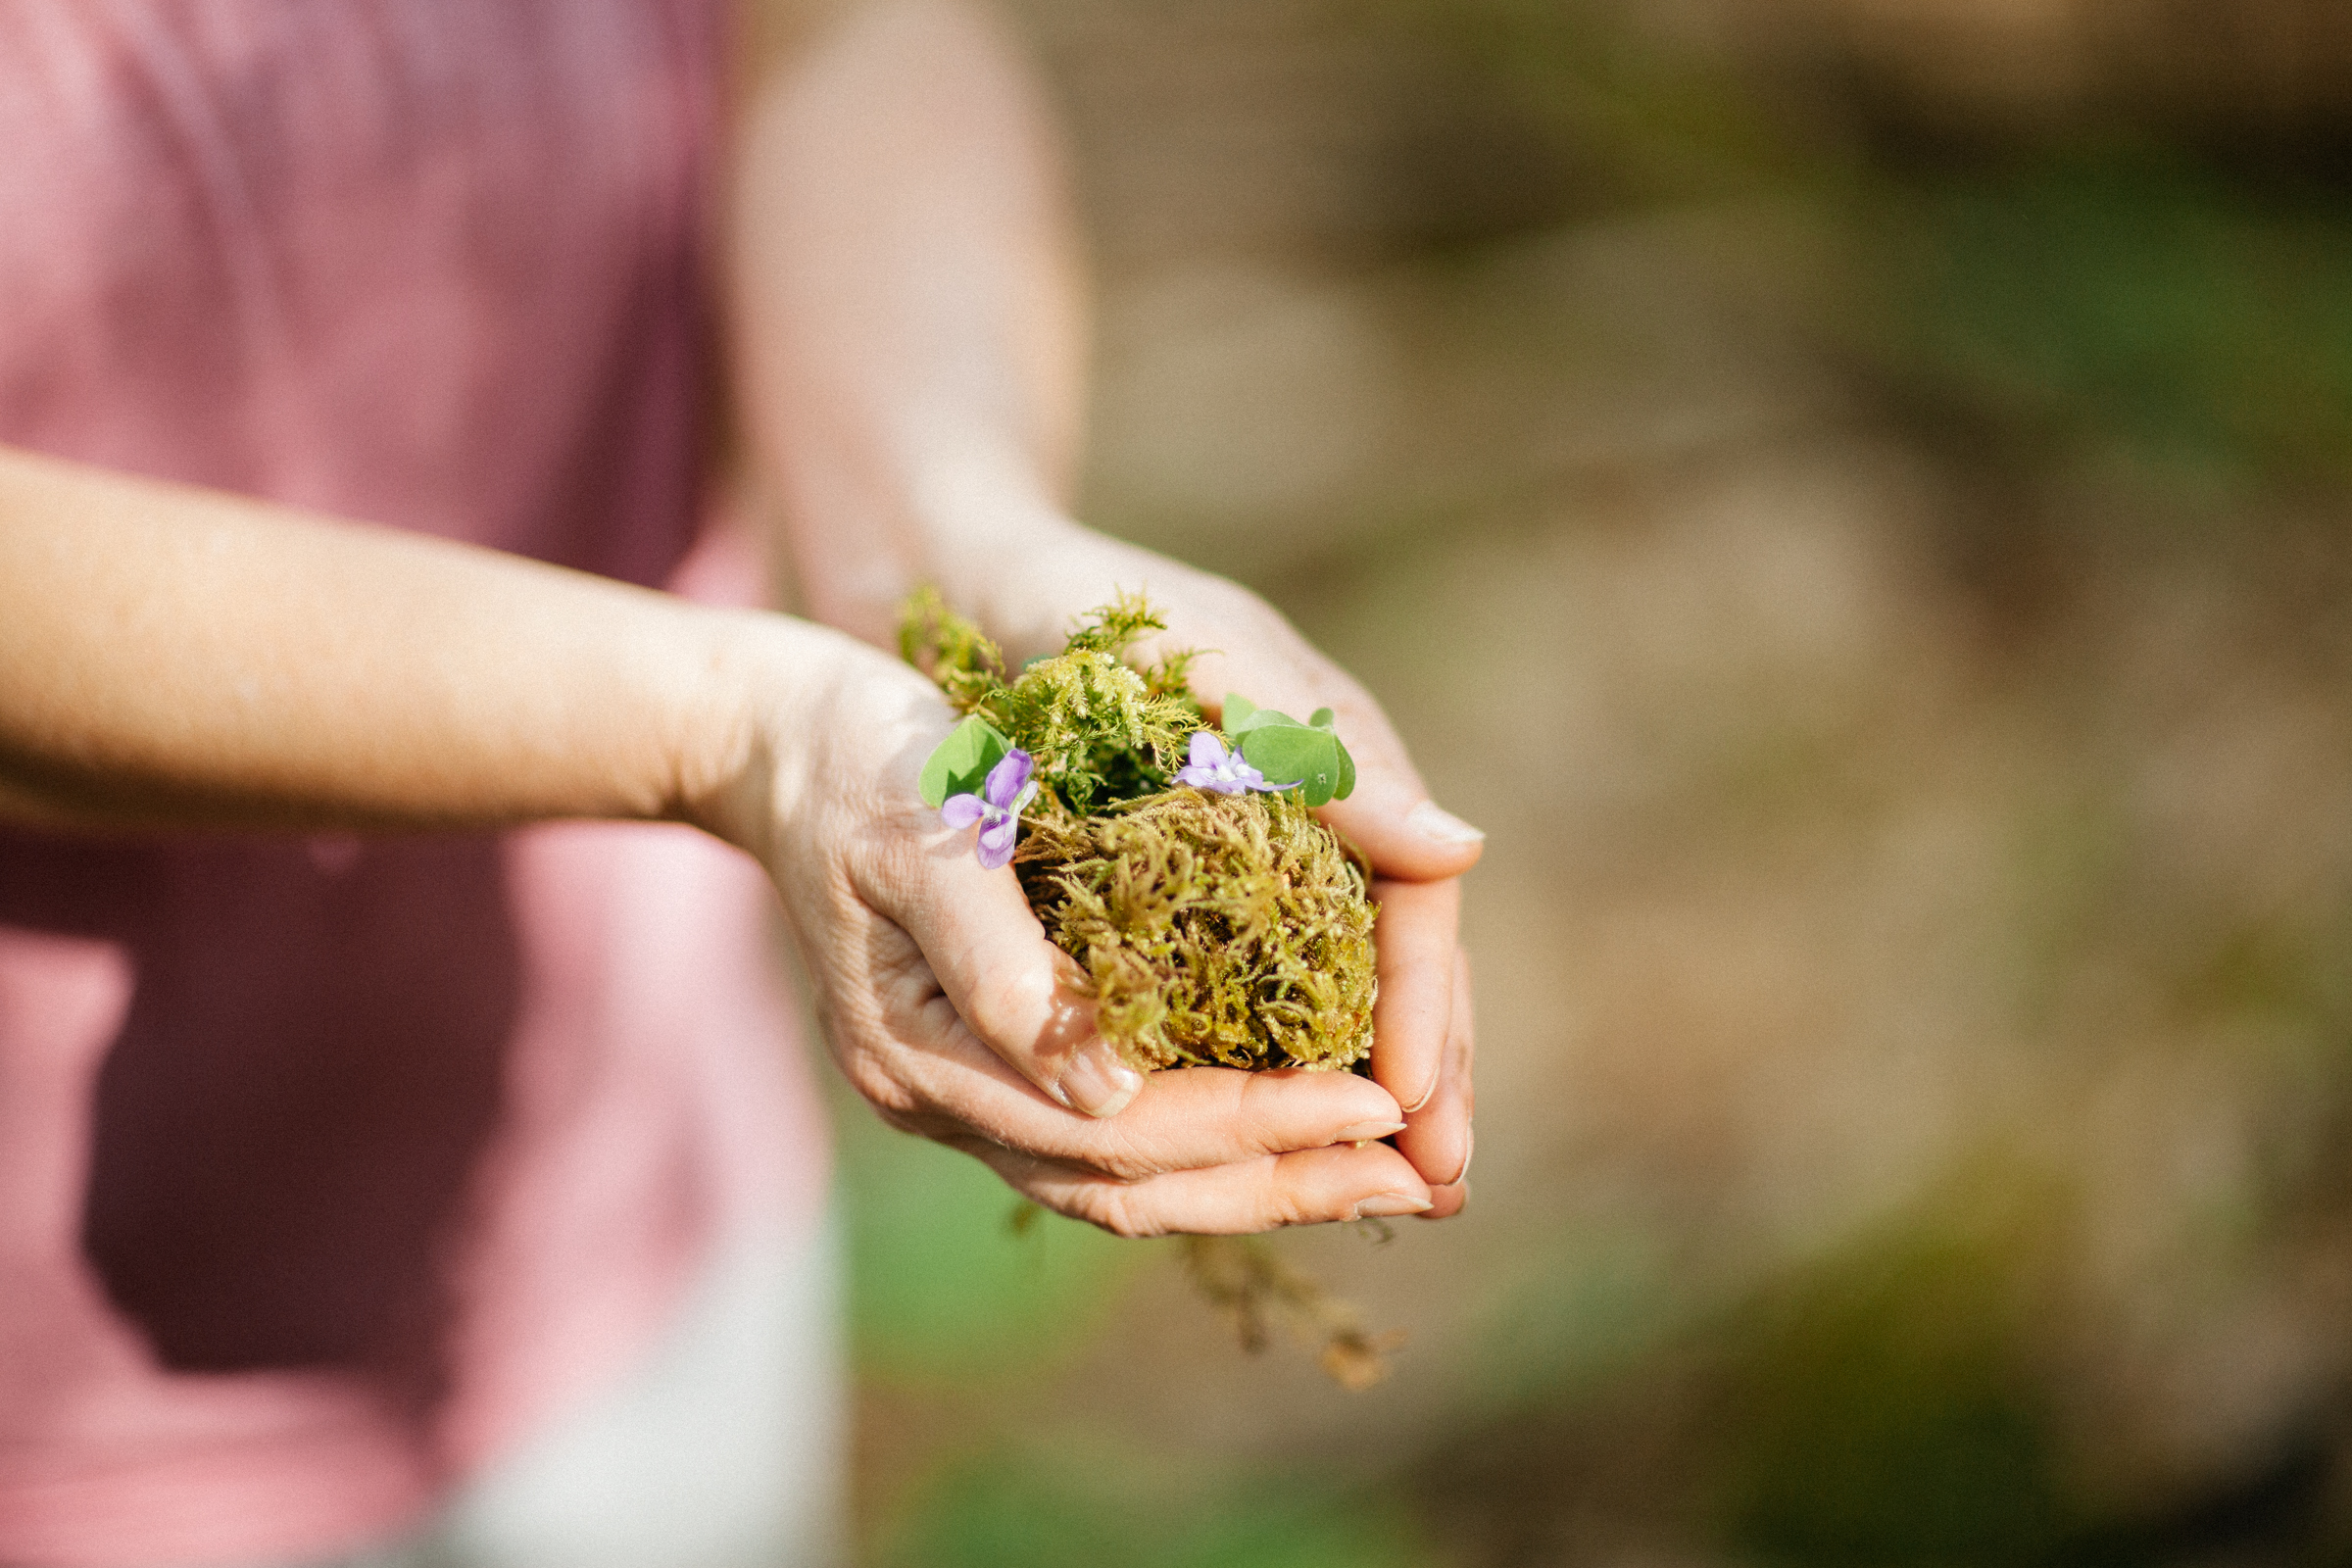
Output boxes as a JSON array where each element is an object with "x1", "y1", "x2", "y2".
[{"x1": 899, "y1": 590, "x2": 1376, "y2": 1069}]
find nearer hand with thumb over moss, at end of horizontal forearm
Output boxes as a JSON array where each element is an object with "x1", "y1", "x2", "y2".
[{"x1": 710, "y1": 618, "x2": 1442, "y2": 1237}]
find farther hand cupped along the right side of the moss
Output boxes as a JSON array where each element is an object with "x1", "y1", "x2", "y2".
[{"x1": 946, "y1": 522, "x2": 1484, "y2": 1220}]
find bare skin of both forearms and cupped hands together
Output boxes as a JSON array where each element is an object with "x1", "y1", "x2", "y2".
[{"x1": 0, "y1": 2, "x2": 1477, "y2": 1234}]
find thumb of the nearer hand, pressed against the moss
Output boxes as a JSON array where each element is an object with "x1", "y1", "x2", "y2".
[{"x1": 865, "y1": 832, "x2": 1143, "y2": 1116}]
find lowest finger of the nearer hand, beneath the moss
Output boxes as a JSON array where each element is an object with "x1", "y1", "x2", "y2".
[{"x1": 971, "y1": 1143, "x2": 1430, "y2": 1237}]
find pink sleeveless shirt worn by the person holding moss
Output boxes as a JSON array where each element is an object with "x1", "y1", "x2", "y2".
[{"x1": 0, "y1": 0, "x2": 823, "y2": 1568}]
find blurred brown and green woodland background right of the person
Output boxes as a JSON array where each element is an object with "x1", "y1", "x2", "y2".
[{"x1": 840, "y1": 0, "x2": 2352, "y2": 1568}]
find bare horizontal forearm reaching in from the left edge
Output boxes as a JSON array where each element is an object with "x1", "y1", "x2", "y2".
[{"x1": 0, "y1": 452, "x2": 800, "y2": 827}]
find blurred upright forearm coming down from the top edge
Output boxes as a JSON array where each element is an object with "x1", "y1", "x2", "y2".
[{"x1": 727, "y1": 0, "x2": 1084, "y2": 642}]
